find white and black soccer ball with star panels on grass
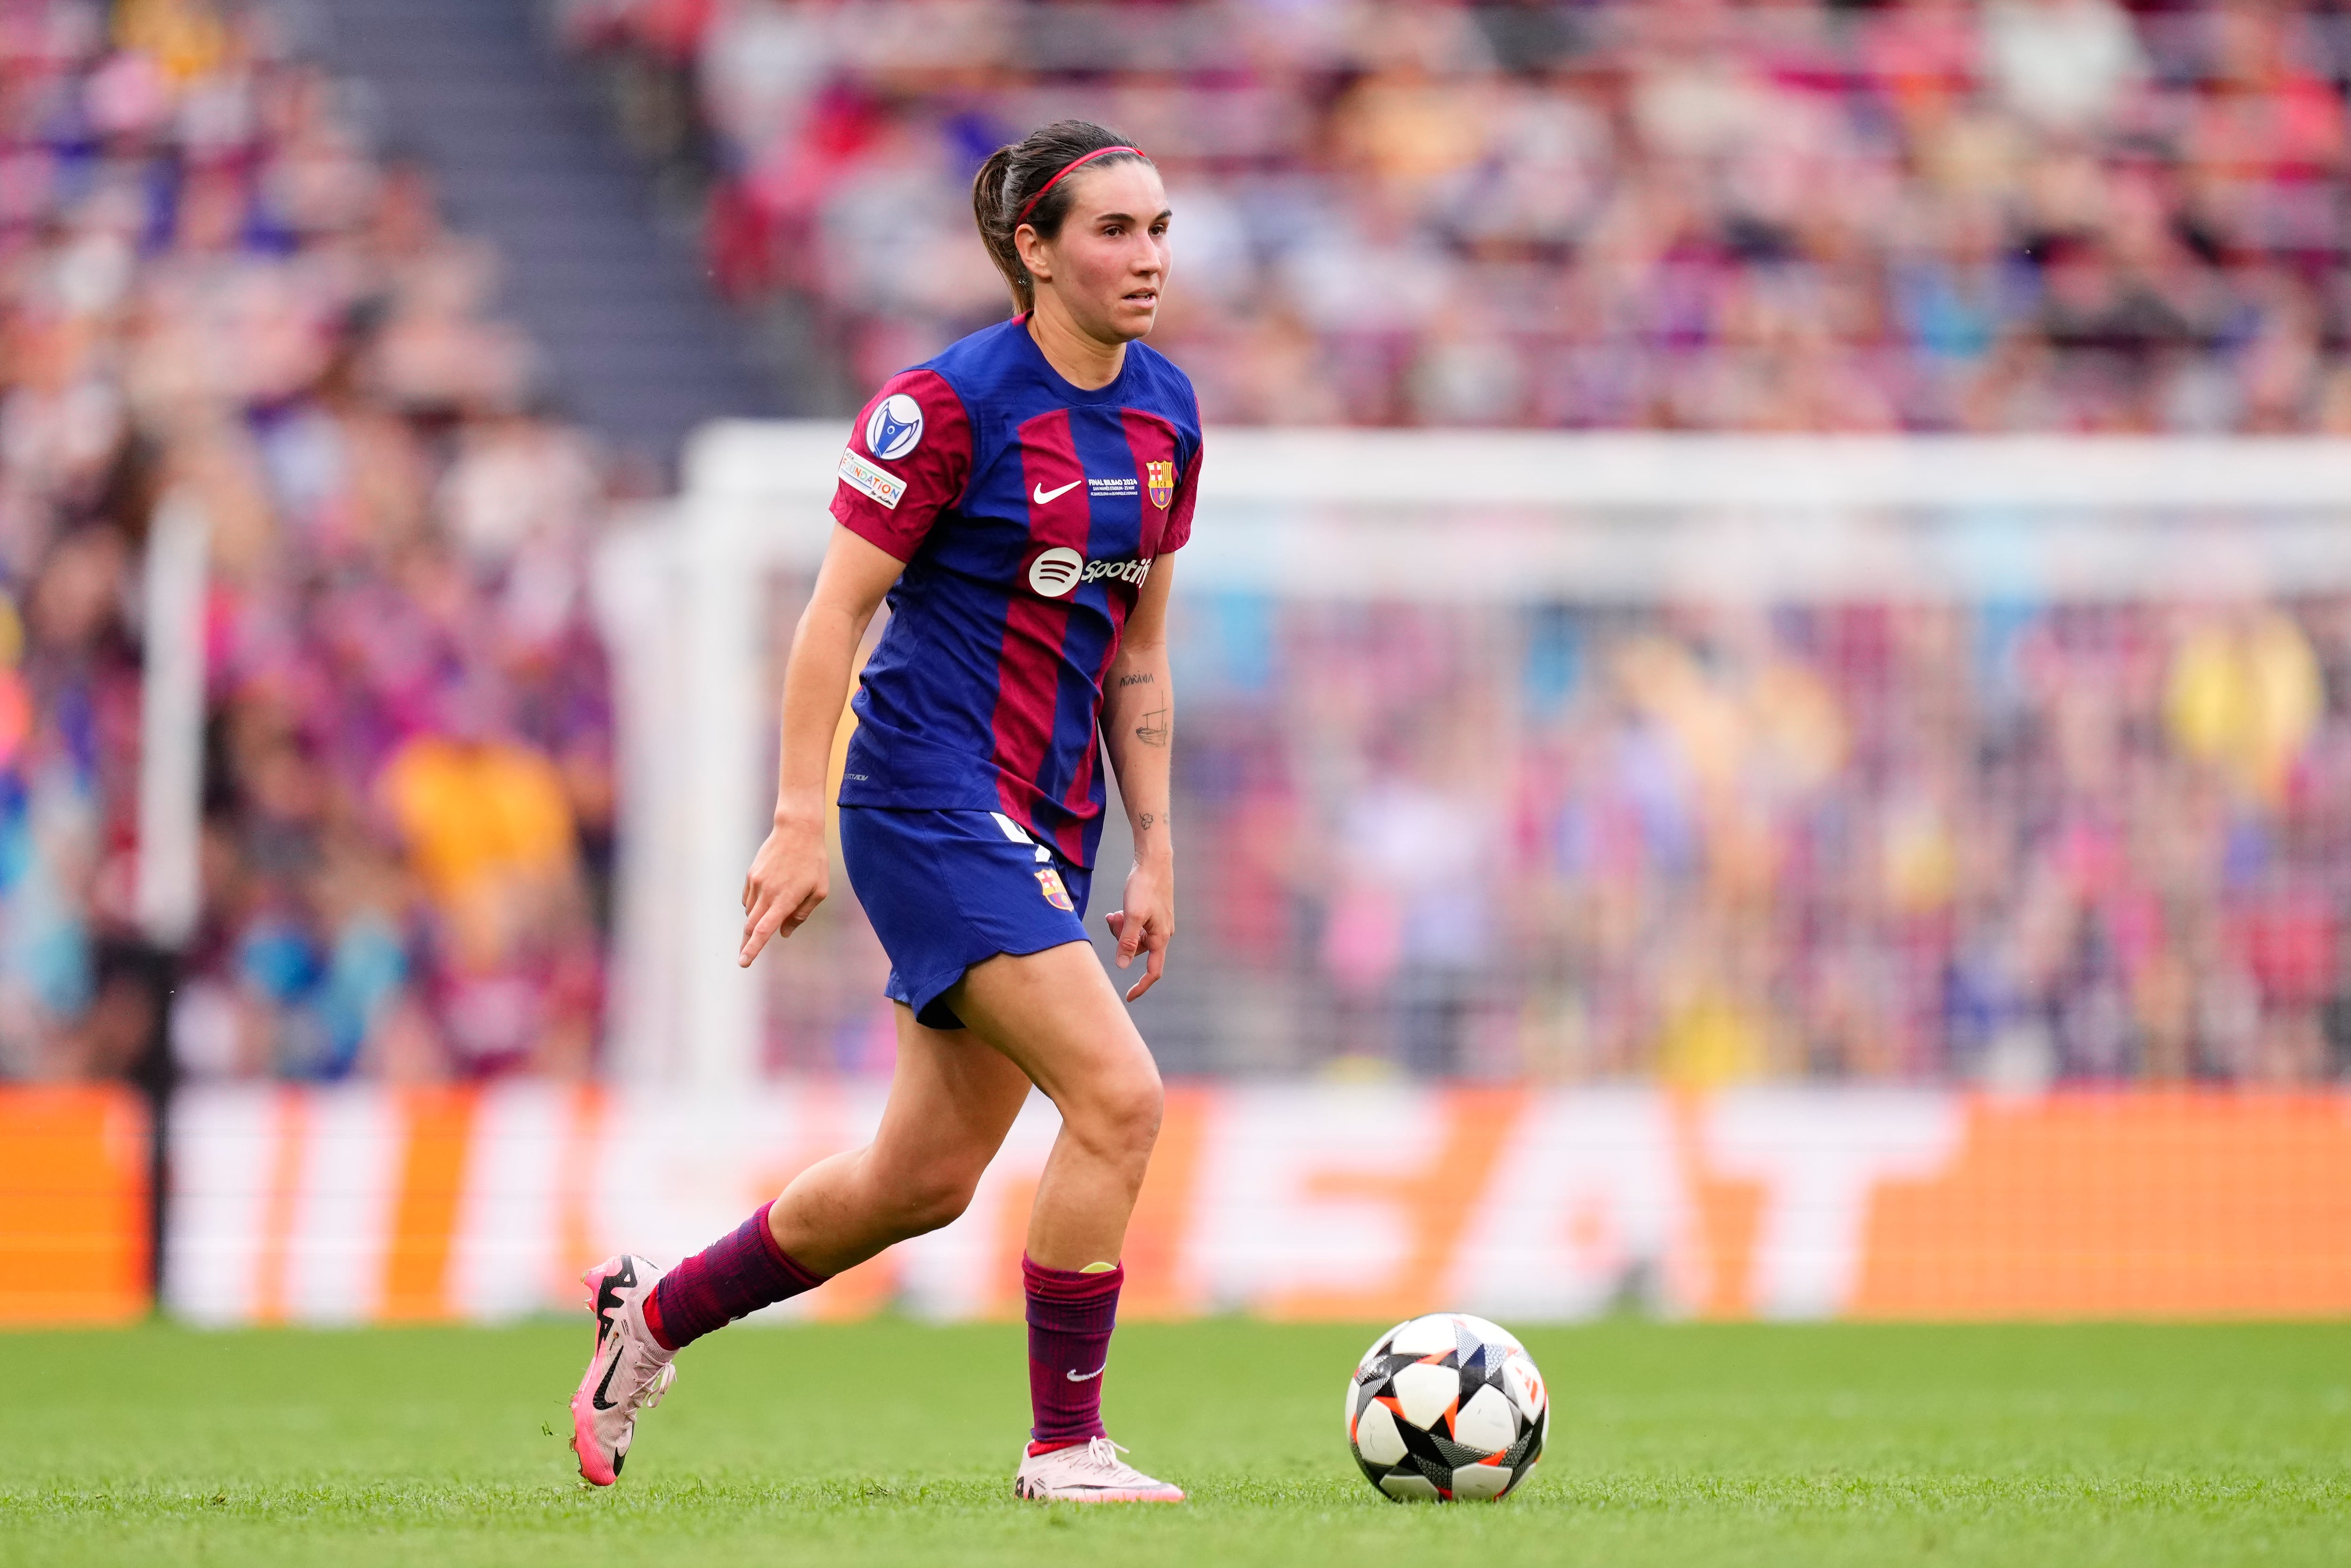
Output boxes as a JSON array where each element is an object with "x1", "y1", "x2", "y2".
[{"x1": 1347, "y1": 1312, "x2": 1552, "y2": 1502}]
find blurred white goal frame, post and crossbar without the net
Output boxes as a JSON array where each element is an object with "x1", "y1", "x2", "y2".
[{"x1": 597, "y1": 421, "x2": 2351, "y2": 1088}]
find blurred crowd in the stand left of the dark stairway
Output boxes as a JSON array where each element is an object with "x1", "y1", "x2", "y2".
[{"x1": 0, "y1": 0, "x2": 614, "y2": 1081}]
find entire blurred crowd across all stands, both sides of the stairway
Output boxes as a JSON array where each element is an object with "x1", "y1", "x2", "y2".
[{"x1": 0, "y1": 0, "x2": 2351, "y2": 1086}]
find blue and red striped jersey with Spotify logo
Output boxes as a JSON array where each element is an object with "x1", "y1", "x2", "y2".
[{"x1": 832, "y1": 317, "x2": 1201, "y2": 865}]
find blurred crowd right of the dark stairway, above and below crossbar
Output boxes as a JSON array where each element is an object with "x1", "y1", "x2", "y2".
[{"x1": 569, "y1": 0, "x2": 2351, "y2": 1084}]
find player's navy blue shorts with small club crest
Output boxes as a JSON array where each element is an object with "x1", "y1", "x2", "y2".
[{"x1": 842, "y1": 806, "x2": 1093, "y2": 1030}]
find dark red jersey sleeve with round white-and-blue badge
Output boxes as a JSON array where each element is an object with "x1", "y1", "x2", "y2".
[{"x1": 832, "y1": 369, "x2": 971, "y2": 562}]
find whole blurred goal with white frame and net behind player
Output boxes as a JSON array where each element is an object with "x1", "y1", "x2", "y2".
[{"x1": 600, "y1": 423, "x2": 2351, "y2": 1086}]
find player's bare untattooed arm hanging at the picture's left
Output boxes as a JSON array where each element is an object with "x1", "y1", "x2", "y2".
[{"x1": 736, "y1": 529, "x2": 905, "y2": 966}]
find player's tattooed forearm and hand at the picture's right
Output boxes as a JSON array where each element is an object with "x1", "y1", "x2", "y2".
[{"x1": 1103, "y1": 552, "x2": 1176, "y2": 1001}]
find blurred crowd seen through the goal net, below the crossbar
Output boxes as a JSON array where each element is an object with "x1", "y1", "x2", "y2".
[{"x1": 769, "y1": 590, "x2": 2351, "y2": 1091}]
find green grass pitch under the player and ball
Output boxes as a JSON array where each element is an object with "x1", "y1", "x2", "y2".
[{"x1": 0, "y1": 1321, "x2": 2351, "y2": 1568}]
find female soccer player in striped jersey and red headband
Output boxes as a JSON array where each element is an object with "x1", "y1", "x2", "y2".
[{"x1": 571, "y1": 120, "x2": 1201, "y2": 1502}]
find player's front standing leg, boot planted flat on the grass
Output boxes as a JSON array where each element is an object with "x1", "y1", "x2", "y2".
[{"x1": 950, "y1": 943, "x2": 1183, "y2": 1502}]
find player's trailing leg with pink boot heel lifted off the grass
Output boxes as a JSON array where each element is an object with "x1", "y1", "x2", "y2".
[{"x1": 571, "y1": 1006, "x2": 1030, "y2": 1486}]
